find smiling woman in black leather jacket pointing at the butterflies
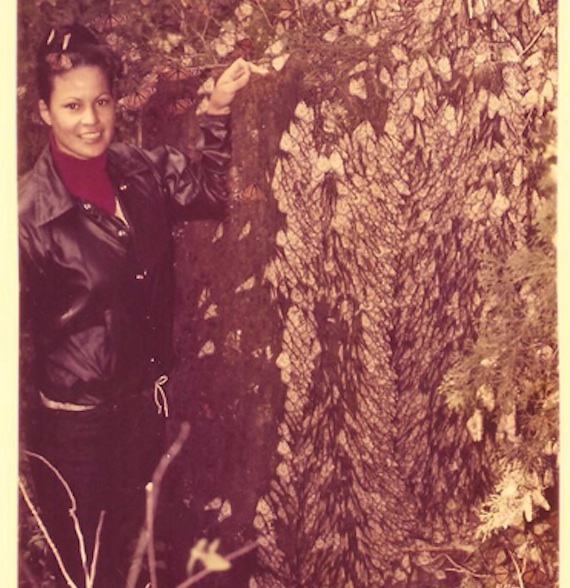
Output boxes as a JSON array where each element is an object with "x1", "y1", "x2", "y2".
[{"x1": 19, "y1": 25, "x2": 250, "y2": 588}]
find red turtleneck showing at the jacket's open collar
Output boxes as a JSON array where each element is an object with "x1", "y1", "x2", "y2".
[{"x1": 50, "y1": 133, "x2": 116, "y2": 214}]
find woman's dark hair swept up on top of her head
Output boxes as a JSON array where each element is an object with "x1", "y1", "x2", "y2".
[{"x1": 36, "y1": 24, "x2": 121, "y2": 104}]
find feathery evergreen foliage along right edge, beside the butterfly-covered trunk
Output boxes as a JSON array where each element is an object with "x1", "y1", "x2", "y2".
[{"x1": 440, "y1": 109, "x2": 559, "y2": 537}]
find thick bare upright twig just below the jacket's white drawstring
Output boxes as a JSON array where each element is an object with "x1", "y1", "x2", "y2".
[{"x1": 126, "y1": 423, "x2": 190, "y2": 588}]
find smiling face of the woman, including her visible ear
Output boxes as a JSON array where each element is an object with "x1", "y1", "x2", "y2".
[{"x1": 39, "y1": 65, "x2": 115, "y2": 159}]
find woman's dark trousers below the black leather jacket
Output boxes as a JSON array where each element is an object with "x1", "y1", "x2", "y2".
[{"x1": 30, "y1": 395, "x2": 164, "y2": 588}]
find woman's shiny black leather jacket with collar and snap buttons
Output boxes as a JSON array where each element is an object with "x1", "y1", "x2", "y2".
[{"x1": 19, "y1": 116, "x2": 230, "y2": 405}]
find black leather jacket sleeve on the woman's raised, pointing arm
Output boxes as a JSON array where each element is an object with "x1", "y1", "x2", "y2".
[{"x1": 142, "y1": 115, "x2": 231, "y2": 218}]
